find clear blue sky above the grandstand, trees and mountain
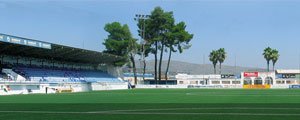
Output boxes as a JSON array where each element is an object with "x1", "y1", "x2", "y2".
[{"x1": 0, "y1": 0, "x2": 300, "y2": 69}]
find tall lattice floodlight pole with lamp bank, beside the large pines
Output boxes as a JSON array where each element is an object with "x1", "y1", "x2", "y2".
[{"x1": 134, "y1": 14, "x2": 149, "y2": 80}]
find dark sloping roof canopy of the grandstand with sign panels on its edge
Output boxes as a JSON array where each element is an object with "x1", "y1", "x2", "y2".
[{"x1": 0, "y1": 34, "x2": 122, "y2": 64}]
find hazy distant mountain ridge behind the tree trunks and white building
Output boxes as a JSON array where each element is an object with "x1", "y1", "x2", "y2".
[{"x1": 127, "y1": 60, "x2": 265, "y2": 75}]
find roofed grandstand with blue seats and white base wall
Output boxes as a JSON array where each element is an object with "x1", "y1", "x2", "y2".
[{"x1": 0, "y1": 34, "x2": 128, "y2": 95}]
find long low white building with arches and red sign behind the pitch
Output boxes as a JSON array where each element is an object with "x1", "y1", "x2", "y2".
[{"x1": 137, "y1": 70, "x2": 300, "y2": 89}]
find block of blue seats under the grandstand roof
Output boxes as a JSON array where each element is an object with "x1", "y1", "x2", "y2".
[{"x1": 14, "y1": 67, "x2": 122, "y2": 83}]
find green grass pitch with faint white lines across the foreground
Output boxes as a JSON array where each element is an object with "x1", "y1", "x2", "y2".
[{"x1": 0, "y1": 89, "x2": 300, "y2": 120}]
